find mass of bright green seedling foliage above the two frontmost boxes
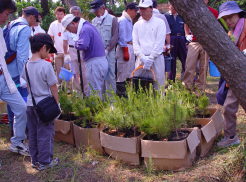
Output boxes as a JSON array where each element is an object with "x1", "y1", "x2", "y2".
[{"x1": 96, "y1": 84, "x2": 195, "y2": 138}]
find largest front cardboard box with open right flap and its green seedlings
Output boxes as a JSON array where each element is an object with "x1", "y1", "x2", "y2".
[{"x1": 140, "y1": 85, "x2": 200, "y2": 170}]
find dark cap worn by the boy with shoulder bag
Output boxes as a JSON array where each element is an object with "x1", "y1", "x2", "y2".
[{"x1": 32, "y1": 33, "x2": 57, "y2": 53}]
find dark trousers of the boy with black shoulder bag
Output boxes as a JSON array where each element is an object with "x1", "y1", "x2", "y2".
[{"x1": 27, "y1": 106, "x2": 54, "y2": 165}]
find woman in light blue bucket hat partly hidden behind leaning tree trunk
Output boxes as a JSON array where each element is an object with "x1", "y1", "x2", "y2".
[{"x1": 217, "y1": 1, "x2": 246, "y2": 147}]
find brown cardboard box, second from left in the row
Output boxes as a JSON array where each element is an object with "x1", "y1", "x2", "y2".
[{"x1": 73, "y1": 124, "x2": 103, "y2": 154}]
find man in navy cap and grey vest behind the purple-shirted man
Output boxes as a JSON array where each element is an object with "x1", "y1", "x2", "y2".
[{"x1": 90, "y1": 0, "x2": 119, "y2": 92}]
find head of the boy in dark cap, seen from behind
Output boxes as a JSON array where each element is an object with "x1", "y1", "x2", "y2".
[{"x1": 30, "y1": 33, "x2": 57, "y2": 59}]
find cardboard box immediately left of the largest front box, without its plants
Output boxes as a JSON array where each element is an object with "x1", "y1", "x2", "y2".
[{"x1": 100, "y1": 131, "x2": 142, "y2": 165}]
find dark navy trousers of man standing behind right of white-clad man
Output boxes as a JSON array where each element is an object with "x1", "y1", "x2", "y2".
[{"x1": 168, "y1": 36, "x2": 187, "y2": 81}]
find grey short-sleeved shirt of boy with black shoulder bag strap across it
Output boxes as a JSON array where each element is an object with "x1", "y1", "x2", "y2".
[{"x1": 22, "y1": 59, "x2": 58, "y2": 106}]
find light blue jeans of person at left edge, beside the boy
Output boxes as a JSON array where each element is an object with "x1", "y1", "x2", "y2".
[{"x1": 0, "y1": 74, "x2": 27, "y2": 145}]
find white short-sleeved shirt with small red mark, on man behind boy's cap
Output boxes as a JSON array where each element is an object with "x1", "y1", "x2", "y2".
[{"x1": 48, "y1": 20, "x2": 65, "y2": 53}]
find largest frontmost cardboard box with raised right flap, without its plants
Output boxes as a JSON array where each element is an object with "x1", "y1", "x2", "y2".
[{"x1": 141, "y1": 128, "x2": 200, "y2": 170}]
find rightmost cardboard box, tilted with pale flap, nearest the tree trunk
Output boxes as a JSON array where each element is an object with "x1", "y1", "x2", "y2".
[{"x1": 195, "y1": 109, "x2": 224, "y2": 157}]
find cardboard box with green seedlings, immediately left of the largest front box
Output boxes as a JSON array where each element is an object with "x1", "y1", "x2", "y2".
[{"x1": 97, "y1": 85, "x2": 146, "y2": 165}]
